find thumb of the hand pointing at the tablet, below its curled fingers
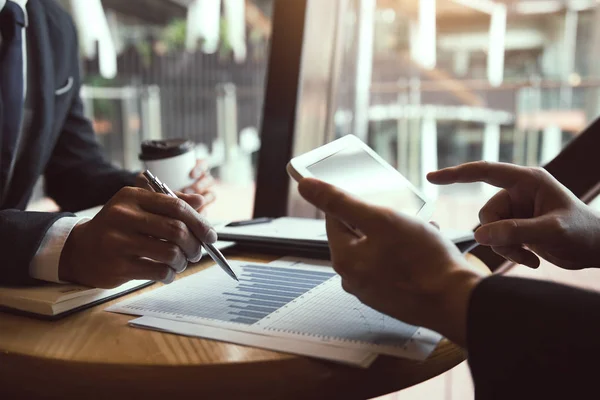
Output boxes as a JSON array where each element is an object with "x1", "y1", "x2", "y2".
[{"x1": 475, "y1": 216, "x2": 556, "y2": 246}]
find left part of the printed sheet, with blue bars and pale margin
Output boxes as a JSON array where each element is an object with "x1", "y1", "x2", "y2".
[{"x1": 113, "y1": 264, "x2": 335, "y2": 325}]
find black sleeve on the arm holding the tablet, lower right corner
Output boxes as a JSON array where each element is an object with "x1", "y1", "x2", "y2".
[{"x1": 467, "y1": 276, "x2": 600, "y2": 399}]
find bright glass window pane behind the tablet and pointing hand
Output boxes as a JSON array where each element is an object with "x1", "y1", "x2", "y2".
[{"x1": 292, "y1": 0, "x2": 600, "y2": 229}]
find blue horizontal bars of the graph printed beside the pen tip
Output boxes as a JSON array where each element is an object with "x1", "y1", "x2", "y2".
[{"x1": 223, "y1": 265, "x2": 335, "y2": 325}]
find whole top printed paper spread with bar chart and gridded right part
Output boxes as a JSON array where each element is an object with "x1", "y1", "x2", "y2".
[{"x1": 107, "y1": 262, "x2": 441, "y2": 360}]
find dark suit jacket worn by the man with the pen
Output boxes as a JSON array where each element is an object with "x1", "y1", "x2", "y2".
[{"x1": 0, "y1": 0, "x2": 135, "y2": 284}]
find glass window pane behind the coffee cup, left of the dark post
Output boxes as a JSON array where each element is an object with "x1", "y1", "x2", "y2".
[{"x1": 49, "y1": 0, "x2": 273, "y2": 220}]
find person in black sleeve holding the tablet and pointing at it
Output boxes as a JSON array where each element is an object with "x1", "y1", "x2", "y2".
[{"x1": 299, "y1": 163, "x2": 600, "y2": 399}]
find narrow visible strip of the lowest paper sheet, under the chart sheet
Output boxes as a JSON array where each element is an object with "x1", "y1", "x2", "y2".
[{"x1": 129, "y1": 317, "x2": 377, "y2": 368}]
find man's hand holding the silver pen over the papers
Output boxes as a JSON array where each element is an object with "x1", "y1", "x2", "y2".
[{"x1": 59, "y1": 183, "x2": 217, "y2": 288}]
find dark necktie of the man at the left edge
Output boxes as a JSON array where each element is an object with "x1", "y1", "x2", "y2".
[{"x1": 0, "y1": 1, "x2": 25, "y2": 190}]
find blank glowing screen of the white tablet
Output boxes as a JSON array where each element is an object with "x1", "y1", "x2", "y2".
[{"x1": 307, "y1": 148, "x2": 425, "y2": 215}]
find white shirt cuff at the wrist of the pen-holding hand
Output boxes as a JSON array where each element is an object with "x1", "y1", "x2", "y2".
[{"x1": 29, "y1": 217, "x2": 90, "y2": 283}]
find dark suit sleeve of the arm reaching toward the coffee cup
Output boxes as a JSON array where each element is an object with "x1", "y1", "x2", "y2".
[{"x1": 45, "y1": 19, "x2": 135, "y2": 211}]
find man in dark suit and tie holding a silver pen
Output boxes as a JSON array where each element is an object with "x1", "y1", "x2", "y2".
[{"x1": 0, "y1": 0, "x2": 216, "y2": 287}]
